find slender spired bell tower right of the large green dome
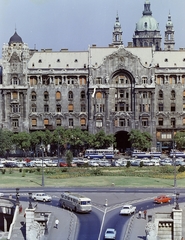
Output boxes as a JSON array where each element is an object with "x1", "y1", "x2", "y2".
[{"x1": 164, "y1": 13, "x2": 175, "y2": 51}]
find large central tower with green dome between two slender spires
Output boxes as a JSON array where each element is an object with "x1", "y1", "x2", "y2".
[{"x1": 133, "y1": 0, "x2": 162, "y2": 50}]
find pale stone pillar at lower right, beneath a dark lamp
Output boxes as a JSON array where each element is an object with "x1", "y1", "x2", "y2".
[{"x1": 172, "y1": 209, "x2": 182, "y2": 240}]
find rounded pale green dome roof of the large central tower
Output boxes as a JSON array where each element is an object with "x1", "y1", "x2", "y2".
[{"x1": 136, "y1": 15, "x2": 159, "y2": 31}]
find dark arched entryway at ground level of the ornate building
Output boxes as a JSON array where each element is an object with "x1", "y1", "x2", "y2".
[{"x1": 115, "y1": 131, "x2": 131, "y2": 153}]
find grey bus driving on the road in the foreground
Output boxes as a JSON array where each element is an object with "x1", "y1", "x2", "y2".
[{"x1": 59, "y1": 192, "x2": 92, "y2": 213}]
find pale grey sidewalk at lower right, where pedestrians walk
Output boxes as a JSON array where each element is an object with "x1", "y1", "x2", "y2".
[{"x1": 124, "y1": 203, "x2": 185, "y2": 240}]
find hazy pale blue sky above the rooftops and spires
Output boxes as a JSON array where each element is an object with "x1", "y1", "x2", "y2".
[{"x1": 0, "y1": 0, "x2": 185, "y2": 55}]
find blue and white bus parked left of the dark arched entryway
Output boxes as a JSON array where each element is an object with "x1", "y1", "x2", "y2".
[{"x1": 85, "y1": 148, "x2": 114, "y2": 159}]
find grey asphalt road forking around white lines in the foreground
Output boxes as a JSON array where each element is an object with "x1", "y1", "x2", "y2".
[{"x1": 0, "y1": 188, "x2": 185, "y2": 240}]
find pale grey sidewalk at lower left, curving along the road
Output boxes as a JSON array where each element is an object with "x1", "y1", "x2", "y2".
[{"x1": 11, "y1": 202, "x2": 77, "y2": 240}]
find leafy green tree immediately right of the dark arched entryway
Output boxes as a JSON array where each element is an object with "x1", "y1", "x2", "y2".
[{"x1": 128, "y1": 129, "x2": 152, "y2": 151}]
